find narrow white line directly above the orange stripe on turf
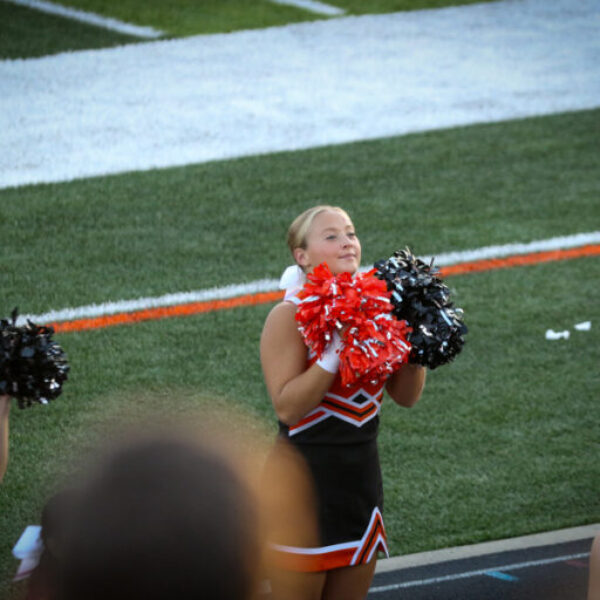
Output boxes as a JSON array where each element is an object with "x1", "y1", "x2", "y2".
[{"x1": 17, "y1": 231, "x2": 600, "y2": 325}]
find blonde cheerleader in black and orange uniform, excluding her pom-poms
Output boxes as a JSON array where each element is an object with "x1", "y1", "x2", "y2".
[{"x1": 260, "y1": 206, "x2": 425, "y2": 600}]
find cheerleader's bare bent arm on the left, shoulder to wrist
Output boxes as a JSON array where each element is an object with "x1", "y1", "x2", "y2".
[{"x1": 260, "y1": 302, "x2": 336, "y2": 425}]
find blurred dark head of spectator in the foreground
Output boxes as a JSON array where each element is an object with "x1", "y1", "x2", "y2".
[{"x1": 59, "y1": 435, "x2": 261, "y2": 600}]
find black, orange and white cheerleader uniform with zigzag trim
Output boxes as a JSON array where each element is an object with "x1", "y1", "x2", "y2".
[{"x1": 272, "y1": 272, "x2": 388, "y2": 572}]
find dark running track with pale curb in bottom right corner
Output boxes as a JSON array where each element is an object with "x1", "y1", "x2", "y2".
[{"x1": 368, "y1": 524, "x2": 600, "y2": 600}]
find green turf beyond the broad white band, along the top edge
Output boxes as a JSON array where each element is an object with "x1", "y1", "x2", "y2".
[{"x1": 0, "y1": 0, "x2": 496, "y2": 59}]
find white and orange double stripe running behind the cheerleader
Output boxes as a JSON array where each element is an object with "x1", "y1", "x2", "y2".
[{"x1": 12, "y1": 231, "x2": 600, "y2": 332}]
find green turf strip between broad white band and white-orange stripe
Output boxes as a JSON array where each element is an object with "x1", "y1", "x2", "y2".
[{"x1": 0, "y1": 111, "x2": 600, "y2": 313}]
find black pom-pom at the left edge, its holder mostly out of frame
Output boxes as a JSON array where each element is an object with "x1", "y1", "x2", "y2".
[{"x1": 0, "y1": 309, "x2": 69, "y2": 408}]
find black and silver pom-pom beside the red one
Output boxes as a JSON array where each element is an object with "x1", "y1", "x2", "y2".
[{"x1": 375, "y1": 248, "x2": 467, "y2": 369}]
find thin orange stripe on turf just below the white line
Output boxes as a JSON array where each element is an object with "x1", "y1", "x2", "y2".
[{"x1": 49, "y1": 244, "x2": 600, "y2": 333}]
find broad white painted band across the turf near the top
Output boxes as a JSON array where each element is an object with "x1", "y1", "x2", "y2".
[{"x1": 0, "y1": 0, "x2": 600, "y2": 189}]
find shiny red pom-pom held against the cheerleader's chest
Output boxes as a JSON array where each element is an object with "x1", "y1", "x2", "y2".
[{"x1": 296, "y1": 263, "x2": 410, "y2": 385}]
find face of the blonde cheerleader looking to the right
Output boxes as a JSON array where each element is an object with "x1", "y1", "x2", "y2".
[{"x1": 294, "y1": 210, "x2": 361, "y2": 275}]
